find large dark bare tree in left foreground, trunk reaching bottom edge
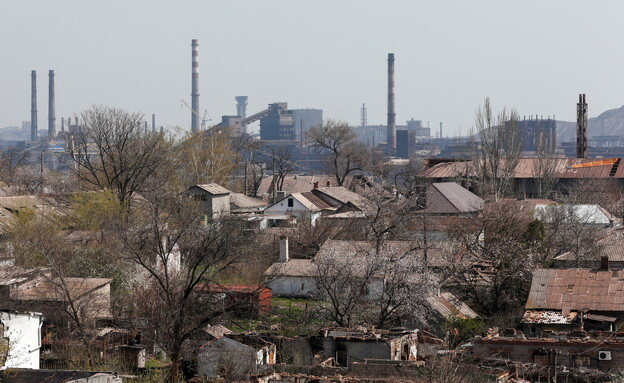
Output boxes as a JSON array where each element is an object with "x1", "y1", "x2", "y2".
[{"x1": 120, "y1": 195, "x2": 241, "y2": 383}]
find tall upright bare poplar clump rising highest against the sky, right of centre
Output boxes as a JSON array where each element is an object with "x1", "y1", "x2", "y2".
[{"x1": 471, "y1": 97, "x2": 522, "y2": 199}]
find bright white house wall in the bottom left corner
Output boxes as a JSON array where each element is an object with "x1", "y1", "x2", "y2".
[{"x1": 0, "y1": 311, "x2": 43, "y2": 370}]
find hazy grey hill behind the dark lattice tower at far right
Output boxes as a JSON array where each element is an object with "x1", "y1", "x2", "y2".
[{"x1": 557, "y1": 106, "x2": 624, "y2": 143}]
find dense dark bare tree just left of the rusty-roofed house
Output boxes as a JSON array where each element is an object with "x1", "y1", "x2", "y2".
[{"x1": 447, "y1": 200, "x2": 535, "y2": 324}]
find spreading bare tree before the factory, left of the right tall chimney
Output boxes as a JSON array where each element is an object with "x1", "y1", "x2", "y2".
[{"x1": 306, "y1": 120, "x2": 370, "y2": 186}]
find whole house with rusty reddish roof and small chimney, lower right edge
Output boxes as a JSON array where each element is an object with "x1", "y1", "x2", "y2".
[{"x1": 521, "y1": 261, "x2": 624, "y2": 337}]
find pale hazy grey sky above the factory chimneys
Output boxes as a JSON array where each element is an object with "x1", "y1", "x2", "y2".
[{"x1": 0, "y1": 0, "x2": 624, "y2": 136}]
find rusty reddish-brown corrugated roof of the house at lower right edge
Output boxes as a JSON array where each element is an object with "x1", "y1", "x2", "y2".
[{"x1": 526, "y1": 269, "x2": 624, "y2": 314}]
